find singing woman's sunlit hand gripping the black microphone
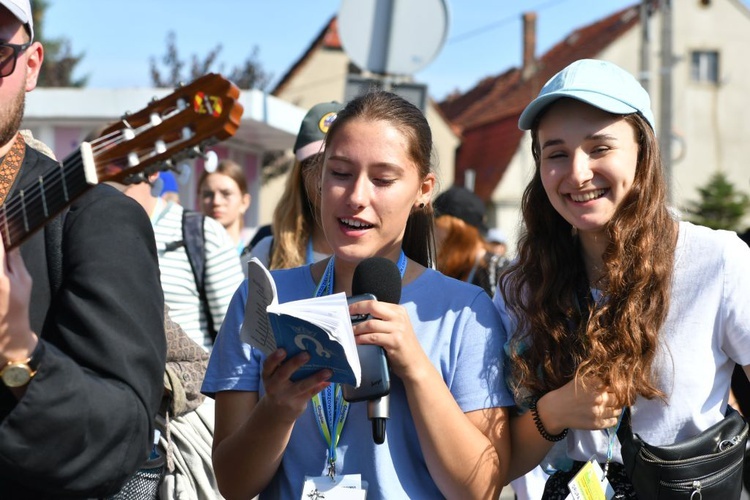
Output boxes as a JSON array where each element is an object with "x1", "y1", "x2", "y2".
[{"x1": 349, "y1": 300, "x2": 429, "y2": 380}]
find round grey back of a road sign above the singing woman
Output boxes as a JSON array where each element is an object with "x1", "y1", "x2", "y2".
[{"x1": 338, "y1": 0, "x2": 448, "y2": 75}]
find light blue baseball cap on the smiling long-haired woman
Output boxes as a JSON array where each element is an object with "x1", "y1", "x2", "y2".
[{"x1": 518, "y1": 59, "x2": 655, "y2": 130}]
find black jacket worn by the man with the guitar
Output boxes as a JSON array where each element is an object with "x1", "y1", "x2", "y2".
[{"x1": 0, "y1": 147, "x2": 166, "y2": 499}]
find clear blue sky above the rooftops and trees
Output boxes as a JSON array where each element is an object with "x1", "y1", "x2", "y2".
[{"x1": 44, "y1": 0, "x2": 750, "y2": 100}]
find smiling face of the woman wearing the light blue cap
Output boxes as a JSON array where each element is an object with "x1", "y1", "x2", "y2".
[{"x1": 537, "y1": 99, "x2": 638, "y2": 237}]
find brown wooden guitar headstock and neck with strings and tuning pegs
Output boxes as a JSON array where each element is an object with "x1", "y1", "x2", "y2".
[{"x1": 0, "y1": 73, "x2": 242, "y2": 250}]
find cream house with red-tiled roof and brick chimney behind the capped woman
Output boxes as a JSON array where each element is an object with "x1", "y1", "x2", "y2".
[{"x1": 440, "y1": 0, "x2": 750, "y2": 256}]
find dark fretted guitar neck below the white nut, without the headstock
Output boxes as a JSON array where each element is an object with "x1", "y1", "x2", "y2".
[{"x1": 0, "y1": 149, "x2": 96, "y2": 250}]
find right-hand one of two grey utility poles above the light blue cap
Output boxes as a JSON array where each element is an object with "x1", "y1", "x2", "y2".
[{"x1": 659, "y1": 0, "x2": 674, "y2": 203}]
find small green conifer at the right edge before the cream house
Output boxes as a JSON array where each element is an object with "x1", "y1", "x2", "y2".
[{"x1": 688, "y1": 172, "x2": 750, "y2": 231}]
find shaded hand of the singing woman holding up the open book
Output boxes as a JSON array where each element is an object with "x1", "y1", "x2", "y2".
[{"x1": 261, "y1": 349, "x2": 333, "y2": 422}]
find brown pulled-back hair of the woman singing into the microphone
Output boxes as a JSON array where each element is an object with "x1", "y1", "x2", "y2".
[{"x1": 325, "y1": 91, "x2": 435, "y2": 267}]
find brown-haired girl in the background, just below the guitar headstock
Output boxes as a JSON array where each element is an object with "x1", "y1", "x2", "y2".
[{"x1": 198, "y1": 160, "x2": 255, "y2": 255}]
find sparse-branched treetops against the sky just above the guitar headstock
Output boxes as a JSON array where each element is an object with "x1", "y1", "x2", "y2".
[{"x1": 151, "y1": 32, "x2": 271, "y2": 90}]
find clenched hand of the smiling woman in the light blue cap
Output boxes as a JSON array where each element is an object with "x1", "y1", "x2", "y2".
[{"x1": 537, "y1": 378, "x2": 622, "y2": 434}]
